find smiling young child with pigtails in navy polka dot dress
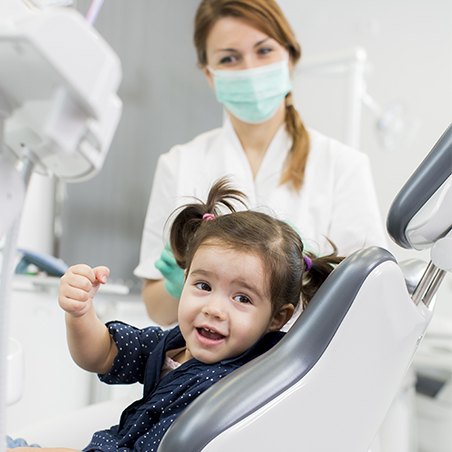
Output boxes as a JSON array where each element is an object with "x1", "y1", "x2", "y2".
[{"x1": 7, "y1": 179, "x2": 341, "y2": 452}]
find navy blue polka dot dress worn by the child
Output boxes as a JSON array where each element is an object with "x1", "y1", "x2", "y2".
[{"x1": 83, "y1": 321, "x2": 284, "y2": 452}]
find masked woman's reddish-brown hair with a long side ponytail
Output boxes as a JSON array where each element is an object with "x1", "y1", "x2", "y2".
[{"x1": 193, "y1": 0, "x2": 310, "y2": 190}]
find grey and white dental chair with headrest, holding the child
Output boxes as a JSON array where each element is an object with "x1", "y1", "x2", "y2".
[{"x1": 10, "y1": 127, "x2": 452, "y2": 452}]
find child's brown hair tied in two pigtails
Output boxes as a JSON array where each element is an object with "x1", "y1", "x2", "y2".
[{"x1": 170, "y1": 178, "x2": 342, "y2": 312}]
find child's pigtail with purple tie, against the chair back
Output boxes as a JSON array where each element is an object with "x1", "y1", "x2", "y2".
[{"x1": 301, "y1": 242, "x2": 344, "y2": 309}]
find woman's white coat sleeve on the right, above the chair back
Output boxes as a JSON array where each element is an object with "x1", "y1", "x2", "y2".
[{"x1": 328, "y1": 152, "x2": 388, "y2": 256}]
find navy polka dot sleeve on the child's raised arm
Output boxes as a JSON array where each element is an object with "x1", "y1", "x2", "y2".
[{"x1": 99, "y1": 321, "x2": 165, "y2": 384}]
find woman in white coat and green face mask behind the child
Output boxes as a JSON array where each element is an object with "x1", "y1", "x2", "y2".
[{"x1": 135, "y1": 0, "x2": 386, "y2": 325}]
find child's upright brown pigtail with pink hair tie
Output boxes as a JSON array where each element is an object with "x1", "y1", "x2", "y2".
[{"x1": 170, "y1": 178, "x2": 246, "y2": 268}]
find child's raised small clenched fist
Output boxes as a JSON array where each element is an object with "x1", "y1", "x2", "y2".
[{"x1": 58, "y1": 264, "x2": 110, "y2": 317}]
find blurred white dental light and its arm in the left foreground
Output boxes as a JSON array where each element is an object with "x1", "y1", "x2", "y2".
[{"x1": 0, "y1": 0, "x2": 122, "y2": 451}]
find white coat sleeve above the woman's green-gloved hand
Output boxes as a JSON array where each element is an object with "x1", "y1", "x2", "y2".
[{"x1": 134, "y1": 151, "x2": 179, "y2": 279}]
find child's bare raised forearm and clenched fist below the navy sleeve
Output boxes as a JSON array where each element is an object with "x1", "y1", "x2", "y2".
[{"x1": 58, "y1": 264, "x2": 118, "y2": 374}]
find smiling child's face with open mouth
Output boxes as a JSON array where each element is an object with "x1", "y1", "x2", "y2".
[{"x1": 179, "y1": 244, "x2": 282, "y2": 363}]
